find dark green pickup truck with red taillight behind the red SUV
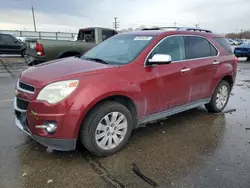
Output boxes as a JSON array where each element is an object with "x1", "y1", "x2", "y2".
[{"x1": 25, "y1": 27, "x2": 117, "y2": 66}]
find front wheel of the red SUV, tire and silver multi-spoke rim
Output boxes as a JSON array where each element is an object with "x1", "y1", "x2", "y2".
[{"x1": 80, "y1": 101, "x2": 132, "y2": 156}]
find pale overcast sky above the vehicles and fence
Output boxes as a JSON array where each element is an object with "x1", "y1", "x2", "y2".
[{"x1": 0, "y1": 0, "x2": 250, "y2": 33}]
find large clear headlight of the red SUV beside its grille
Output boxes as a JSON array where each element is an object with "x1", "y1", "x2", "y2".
[{"x1": 37, "y1": 80, "x2": 79, "y2": 104}]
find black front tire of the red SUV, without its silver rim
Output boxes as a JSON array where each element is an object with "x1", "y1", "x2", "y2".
[{"x1": 80, "y1": 101, "x2": 133, "y2": 156}]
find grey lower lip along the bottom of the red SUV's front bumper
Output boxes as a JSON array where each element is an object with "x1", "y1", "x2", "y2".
[{"x1": 15, "y1": 117, "x2": 77, "y2": 151}]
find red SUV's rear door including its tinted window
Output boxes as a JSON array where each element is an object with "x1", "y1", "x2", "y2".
[{"x1": 185, "y1": 36, "x2": 220, "y2": 102}]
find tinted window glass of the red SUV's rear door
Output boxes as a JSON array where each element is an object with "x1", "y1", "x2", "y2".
[{"x1": 186, "y1": 36, "x2": 218, "y2": 59}]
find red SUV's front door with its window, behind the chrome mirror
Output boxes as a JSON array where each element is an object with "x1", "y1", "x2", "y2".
[{"x1": 146, "y1": 36, "x2": 191, "y2": 111}]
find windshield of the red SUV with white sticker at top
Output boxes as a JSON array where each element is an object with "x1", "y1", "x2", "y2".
[{"x1": 81, "y1": 35, "x2": 154, "y2": 64}]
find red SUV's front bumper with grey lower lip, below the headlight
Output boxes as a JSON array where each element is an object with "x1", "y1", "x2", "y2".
[{"x1": 14, "y1": 94, "x2": 80, "y2": 151}]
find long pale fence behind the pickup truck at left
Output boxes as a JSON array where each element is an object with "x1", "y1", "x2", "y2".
[{"x1": 0, "y1": 30, "x2": 77, "y2": 40}]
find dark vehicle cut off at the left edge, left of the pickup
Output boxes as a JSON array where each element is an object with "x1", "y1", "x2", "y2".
[{"x1": 0, "y1": 33, "x2": 26, "y2": 57}]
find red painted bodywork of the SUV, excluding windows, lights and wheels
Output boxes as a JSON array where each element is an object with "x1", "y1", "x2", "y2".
[{"x1": 15, "y1": 31, "x2": 237, "y2": 152}]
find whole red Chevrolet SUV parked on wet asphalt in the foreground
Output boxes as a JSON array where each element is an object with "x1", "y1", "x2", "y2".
[{"x1": 14, "y1": 28, "x2": 237, "y2": 156}]
